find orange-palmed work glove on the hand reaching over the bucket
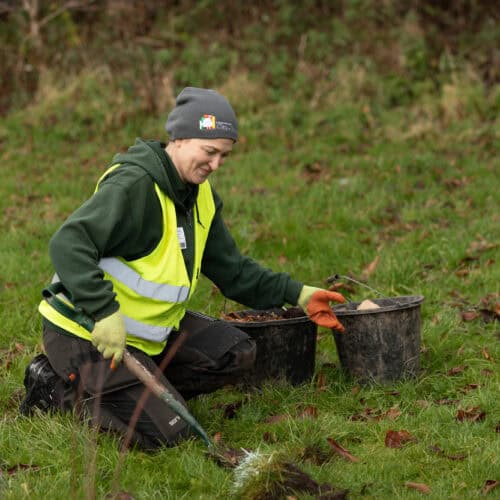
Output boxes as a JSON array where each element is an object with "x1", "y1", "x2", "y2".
[{"x1": 298, "y1": 285, "x2": 345, "y2": 333}]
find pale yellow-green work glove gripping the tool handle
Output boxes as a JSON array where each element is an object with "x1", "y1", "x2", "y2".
[{"x1": 92, "y1": 311, "x2": 127, "y2": 364}]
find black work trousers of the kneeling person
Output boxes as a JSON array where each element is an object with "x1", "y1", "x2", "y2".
[{"x1": 43, "y1": 312, "x2": 256, "y2": 449}]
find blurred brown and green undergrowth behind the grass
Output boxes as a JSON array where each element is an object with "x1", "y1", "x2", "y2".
[{"x1": 0, "y1": 0, "x2": 500, "y2": 120}]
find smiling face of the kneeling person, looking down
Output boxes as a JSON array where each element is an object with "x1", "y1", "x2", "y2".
[{"x1": 166, "y1": 139, "x2": 233, "y2": 184}]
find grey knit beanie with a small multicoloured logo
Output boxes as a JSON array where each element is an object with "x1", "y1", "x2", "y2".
[{"x1": 165, "y1": 87, "x2": 238, "y2": 141}]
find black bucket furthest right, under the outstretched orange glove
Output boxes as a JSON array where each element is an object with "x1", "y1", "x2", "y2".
[{"x1": 332, "y1": 295, "x2": 424, "y2": 383}]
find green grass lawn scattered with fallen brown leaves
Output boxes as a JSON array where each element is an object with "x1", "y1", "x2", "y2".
[{"x1": 0, "y1": 64, "x2": 500, "y2": 500}]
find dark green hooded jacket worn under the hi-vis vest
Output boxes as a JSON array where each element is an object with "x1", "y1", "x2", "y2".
[{"x1": 49, "y1": 139, "x2": 302, "y2": 320}]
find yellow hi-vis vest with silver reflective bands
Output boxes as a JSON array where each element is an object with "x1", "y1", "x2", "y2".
[{"x1": 38, "y1": 165, "x2": 215, "y2": 355}]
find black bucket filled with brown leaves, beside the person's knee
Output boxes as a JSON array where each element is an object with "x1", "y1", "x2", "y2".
[{"x1": 226, "y1": 308, "x2": 317, "y2": 386}]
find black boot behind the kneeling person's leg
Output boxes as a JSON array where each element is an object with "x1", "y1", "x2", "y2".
[{"x1": 19, "y1": 354, "x2": 61, "y2": 416}]
